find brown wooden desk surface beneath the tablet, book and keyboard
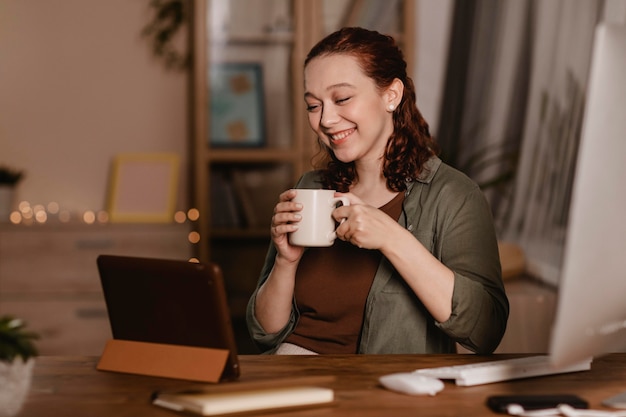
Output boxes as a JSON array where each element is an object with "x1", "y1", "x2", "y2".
[{"x1": 19, "y1": 353, "x2": 626, "y2": 417}]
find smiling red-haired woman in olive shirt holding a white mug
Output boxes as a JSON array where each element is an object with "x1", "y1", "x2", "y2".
[{"x1": 247, "y1": 28, "x2": 509, "y2": 354}]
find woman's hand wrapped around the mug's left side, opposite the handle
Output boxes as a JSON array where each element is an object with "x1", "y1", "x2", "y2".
[{"x1": 270, "y1": 189, "x2": 304, "y2": 262}]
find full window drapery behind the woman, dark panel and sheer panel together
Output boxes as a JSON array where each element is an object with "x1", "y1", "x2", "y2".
[{"x1": 437, "y1": 0, "x2": 604, "y2": 283}]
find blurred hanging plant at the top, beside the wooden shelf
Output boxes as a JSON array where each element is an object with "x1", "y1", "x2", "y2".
[{"x1": 142, "y1": 0, "x2": 190, "y2": 70}]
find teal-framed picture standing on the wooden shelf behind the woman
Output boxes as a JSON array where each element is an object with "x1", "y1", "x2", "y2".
[{"x1": 209, "y1": 63, "x2": 265, "y2": 147}]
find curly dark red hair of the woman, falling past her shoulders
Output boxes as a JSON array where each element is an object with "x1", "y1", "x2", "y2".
[{"x1": 304, "y1": 27, "x2": 439, "y2": 192}]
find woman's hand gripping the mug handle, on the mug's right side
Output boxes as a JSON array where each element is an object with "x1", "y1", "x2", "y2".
[{"x1": 333, "y1": 193, "x2": 399, "y2": 249}]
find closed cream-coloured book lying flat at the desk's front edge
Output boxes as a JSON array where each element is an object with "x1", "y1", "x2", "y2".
[{"x1": 152, "y1": 385, "x2": 334, "y2": 416}]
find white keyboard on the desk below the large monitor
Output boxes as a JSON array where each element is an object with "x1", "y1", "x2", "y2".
[{"x1": 415, "y1": 355, "x2": 591, "y2": 386}]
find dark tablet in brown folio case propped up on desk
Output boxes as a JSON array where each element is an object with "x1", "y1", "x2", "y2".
[{"x1": 97, "y1": 255, "x2": 239, "y2": 379}]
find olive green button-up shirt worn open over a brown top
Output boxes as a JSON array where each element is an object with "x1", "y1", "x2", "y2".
[{"x1": 247, "y1": 157, "x2": 509, "y2": 354}]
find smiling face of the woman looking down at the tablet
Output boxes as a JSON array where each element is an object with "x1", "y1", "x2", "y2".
[{"x1": 304, "y1": 54, "x2": 397, "y2": 163}]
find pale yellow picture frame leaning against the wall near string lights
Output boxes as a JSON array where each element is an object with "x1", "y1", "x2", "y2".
[{"x1": 107, "y1": 153, "x2": 180, "y2": 223}]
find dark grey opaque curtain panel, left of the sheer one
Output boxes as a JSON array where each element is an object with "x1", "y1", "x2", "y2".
[{"x1": 437, "y1": 0, "x2": 532, "y2": 230}]
